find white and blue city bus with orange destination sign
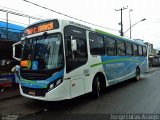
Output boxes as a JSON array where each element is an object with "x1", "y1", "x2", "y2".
[{"x1": 13, "y1": 19, "x2": 148, "y2": 101}]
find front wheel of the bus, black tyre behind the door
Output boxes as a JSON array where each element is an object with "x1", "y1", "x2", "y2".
[{"x1": 92, "y1": 76, "x2": 100, "y2": 98}]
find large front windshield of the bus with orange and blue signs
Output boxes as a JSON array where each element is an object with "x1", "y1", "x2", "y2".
[{"x1": 21, "y1": 34, "x2": 64, "y2": 70}]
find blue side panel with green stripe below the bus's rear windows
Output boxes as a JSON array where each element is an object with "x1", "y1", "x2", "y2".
[{"x1": 101, "y1": 56, "x2": 147, "y2": 85}]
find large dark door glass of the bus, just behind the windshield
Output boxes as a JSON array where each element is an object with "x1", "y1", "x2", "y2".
[{"x1": 64, "y1": 26, "x2": 88, "y2": 73}]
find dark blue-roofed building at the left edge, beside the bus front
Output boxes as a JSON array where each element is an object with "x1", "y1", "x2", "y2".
[{"x1": 0, "y1": 21, "x2": 24, "y2": 75}]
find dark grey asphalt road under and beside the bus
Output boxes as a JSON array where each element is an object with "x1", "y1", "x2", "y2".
[{"x1": 0, "y1": 71, "x2": 160, "y2": 120}]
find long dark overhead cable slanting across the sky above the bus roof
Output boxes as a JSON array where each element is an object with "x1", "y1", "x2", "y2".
[{"x1": 23, "y1": 0, "x2": 119, "y2": 31}]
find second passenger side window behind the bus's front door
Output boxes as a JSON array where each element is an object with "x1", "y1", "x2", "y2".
[{"x1": 106, "y1": 38, "x2": 116, "y2": 56}]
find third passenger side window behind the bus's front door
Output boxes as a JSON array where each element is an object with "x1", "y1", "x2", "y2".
[{"x1": 117, "y1": 40, "x2": 125, "y2": 56}]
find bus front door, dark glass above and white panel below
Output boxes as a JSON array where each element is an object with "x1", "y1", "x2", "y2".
[{"x1": 65, "y1": 26, "x2": 88, "y2": 98}]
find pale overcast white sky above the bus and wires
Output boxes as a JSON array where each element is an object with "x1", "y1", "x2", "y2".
[{"x1": 0, "y1": 0, "x2": 160, "y2": 49}]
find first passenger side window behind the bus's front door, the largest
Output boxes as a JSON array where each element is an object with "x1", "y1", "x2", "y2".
[{"x1": 89, "y1": 33, "x2": 105, "y2": 55}]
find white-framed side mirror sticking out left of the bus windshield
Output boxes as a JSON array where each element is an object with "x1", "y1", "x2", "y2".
[{"x1": 12, "y1": 42, "x2": 21, "y2": 61}]
